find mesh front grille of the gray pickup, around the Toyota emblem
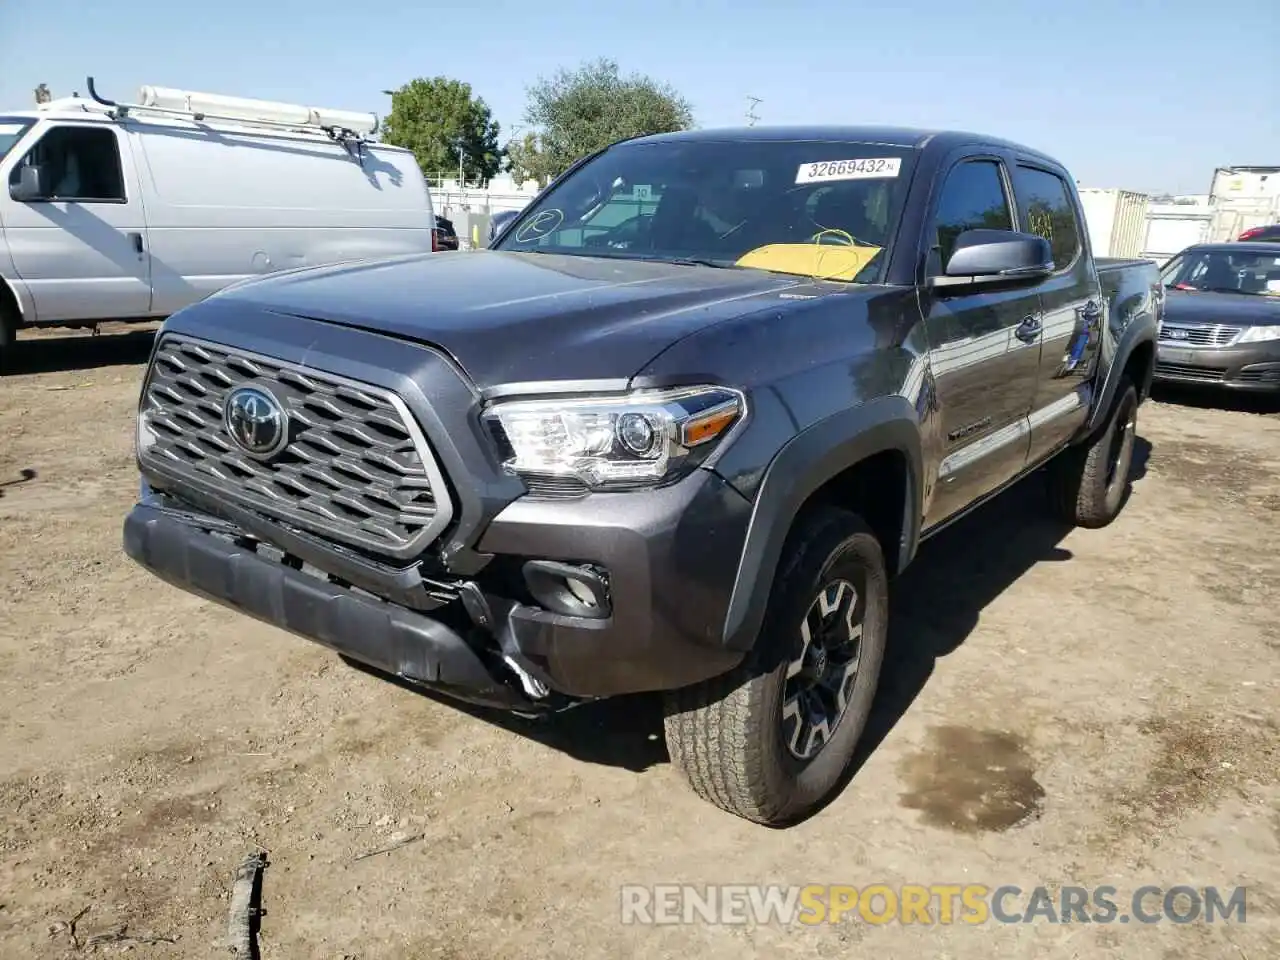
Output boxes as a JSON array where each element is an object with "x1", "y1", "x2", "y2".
[{"x1": 140, "y1": 334, "x2": 452, "y2": 558}]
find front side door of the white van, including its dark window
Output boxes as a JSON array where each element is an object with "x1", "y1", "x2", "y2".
[{"x1": 0, "y1": 122, "x2": 151, "y2": 323}]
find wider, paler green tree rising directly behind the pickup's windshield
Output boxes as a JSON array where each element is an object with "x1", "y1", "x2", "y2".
[{"x1": 521, "y1": 58, "x2": 694, "y2": 179}]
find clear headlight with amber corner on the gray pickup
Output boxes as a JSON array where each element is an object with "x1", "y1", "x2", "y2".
[{"x1": 484, "y1": 387, "x2": 746, "y2": 490}]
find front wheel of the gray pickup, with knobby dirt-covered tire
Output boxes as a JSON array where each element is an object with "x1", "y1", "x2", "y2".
[{"x1": 664, "y1": 508, "x2": 888, "y2": 826}]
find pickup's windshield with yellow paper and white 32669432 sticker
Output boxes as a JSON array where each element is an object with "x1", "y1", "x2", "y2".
[{"x1": 495, "y1": 140, "x2": 915, "y2": 283}]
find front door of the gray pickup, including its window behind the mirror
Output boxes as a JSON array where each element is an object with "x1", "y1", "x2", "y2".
[{"x1": 922, "y1": 156, "x2": 1041, "y2": 526}]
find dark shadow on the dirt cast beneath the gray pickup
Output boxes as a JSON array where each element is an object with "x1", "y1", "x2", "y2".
[{"x1": 358, "y1": 448, "x2": 1151, "y2": 808}]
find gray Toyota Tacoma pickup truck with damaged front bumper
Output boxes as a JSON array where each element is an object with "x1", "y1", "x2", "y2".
[{"x1": 124, "y1": 128, "x2": 1164, "y2": 824}]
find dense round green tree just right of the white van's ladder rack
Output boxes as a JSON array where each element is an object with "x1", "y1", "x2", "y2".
[{"x1": 383, "y1": 77, "x2": 502, "y2": 180}]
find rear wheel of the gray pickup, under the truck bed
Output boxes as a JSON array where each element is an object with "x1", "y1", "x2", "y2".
[{"x1": 1048, "y1": 378, "x2": 1138, "y2": 529}]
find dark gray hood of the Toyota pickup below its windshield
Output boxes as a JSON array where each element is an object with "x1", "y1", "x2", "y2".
[{"x1": 211, "y1": 256, "x2": 819, "y2": 389}]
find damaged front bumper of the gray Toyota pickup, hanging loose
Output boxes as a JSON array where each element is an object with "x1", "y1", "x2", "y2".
[{"x1": 124, "y1": 471, "x2": 750, "y2": 713}]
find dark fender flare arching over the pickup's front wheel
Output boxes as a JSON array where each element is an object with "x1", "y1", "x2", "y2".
[{"x1": 723, "y1": 396, "x2": 923, "y2": 650}]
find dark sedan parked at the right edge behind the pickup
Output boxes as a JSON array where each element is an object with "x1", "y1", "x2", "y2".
[{"x1": 1156, "y1": 242, "x2": 1280, "y2": 392}]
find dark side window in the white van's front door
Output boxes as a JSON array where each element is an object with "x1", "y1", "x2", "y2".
[{"x1": 9, "y1": 127, "x2": 125, "y2": 202}]
